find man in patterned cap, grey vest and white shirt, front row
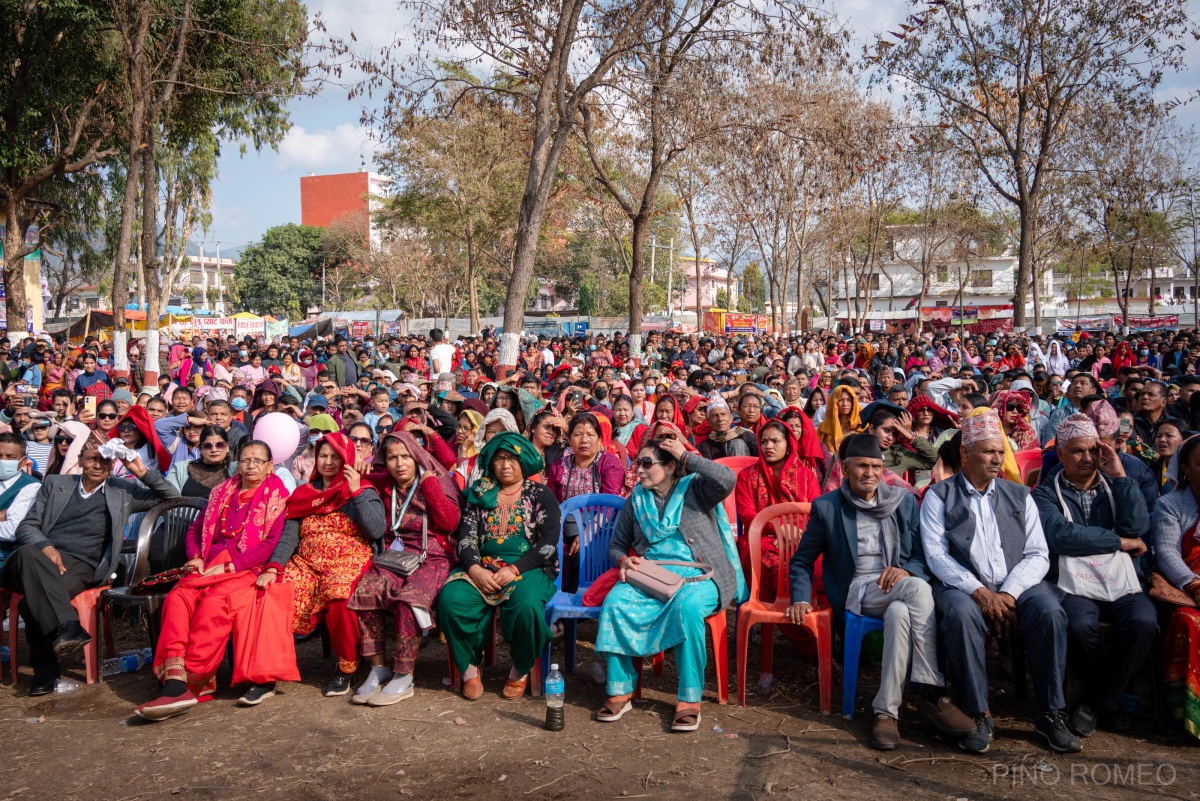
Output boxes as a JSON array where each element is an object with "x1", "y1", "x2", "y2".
[{"x1": 920, "y1": 409, "x2": 1082, "y2": 754}]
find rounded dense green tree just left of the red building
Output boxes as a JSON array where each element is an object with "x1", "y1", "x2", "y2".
[{"x1": 234, "y1": 223, "x2": 325, "y2": 320}]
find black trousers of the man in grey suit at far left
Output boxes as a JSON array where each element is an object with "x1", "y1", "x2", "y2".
[{"x1": 0, "y1": 546, "x2": 96, "y2": 681}]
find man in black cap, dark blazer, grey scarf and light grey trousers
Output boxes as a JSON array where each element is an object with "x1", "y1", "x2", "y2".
[{"x1": 788, "y1": 434, "x2": 974, "y2": 751}]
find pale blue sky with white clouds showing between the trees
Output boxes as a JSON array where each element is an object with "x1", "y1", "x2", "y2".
[{"x1": 206, "y1": 0, "x2": 1200, "y2": 252}]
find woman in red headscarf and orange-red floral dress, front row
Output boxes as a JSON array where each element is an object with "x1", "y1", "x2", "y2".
[{"x1": 257, "y1": 432, "x2": 388, "y2": 698}]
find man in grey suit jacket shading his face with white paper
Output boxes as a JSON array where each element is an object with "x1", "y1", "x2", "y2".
[{"x1": 0, "y1": 434, "x2": 179, "y2": 695}]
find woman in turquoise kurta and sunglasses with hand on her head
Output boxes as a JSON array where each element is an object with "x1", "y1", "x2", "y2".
[{"x1": 596, "y1": 440, "x2": 745, "y2": 731}]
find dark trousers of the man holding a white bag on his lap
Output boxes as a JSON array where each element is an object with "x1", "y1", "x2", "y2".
[{"x1": 1062, "y1": 592, "x2": 1158, "y2": 712}]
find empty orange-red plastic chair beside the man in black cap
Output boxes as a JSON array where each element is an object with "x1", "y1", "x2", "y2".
[{"x1": 738, "y1": 504, "x2": 833, "y2": 715}]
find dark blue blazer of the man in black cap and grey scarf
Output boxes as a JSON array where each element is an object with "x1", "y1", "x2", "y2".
[{"x1": 790, "y1": 489, "x2": 929, "y2": 615}]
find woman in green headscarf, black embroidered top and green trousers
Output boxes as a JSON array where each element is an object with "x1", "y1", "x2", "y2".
[{"x1": 438, "y1": 432, "x2": 559, "y2": 700}]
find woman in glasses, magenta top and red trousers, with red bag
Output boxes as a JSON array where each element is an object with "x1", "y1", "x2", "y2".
[{"x1": 136, "y1": 440, "x2": 300, "y2": 721}]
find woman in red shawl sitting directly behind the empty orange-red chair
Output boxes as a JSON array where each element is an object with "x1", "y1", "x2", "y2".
[{"x1": 733, "y1": 420, "x2": 821, "y2": 694}]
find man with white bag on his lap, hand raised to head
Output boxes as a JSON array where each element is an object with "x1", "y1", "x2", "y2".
[{"x1": 1033, "y1": 412, "x2": 1158, "y2": 737}]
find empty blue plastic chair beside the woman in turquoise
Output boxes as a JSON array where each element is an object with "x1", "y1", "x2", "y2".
[{"x1": 541, "y1": 494, "x2": 625, "y2": 682}]
